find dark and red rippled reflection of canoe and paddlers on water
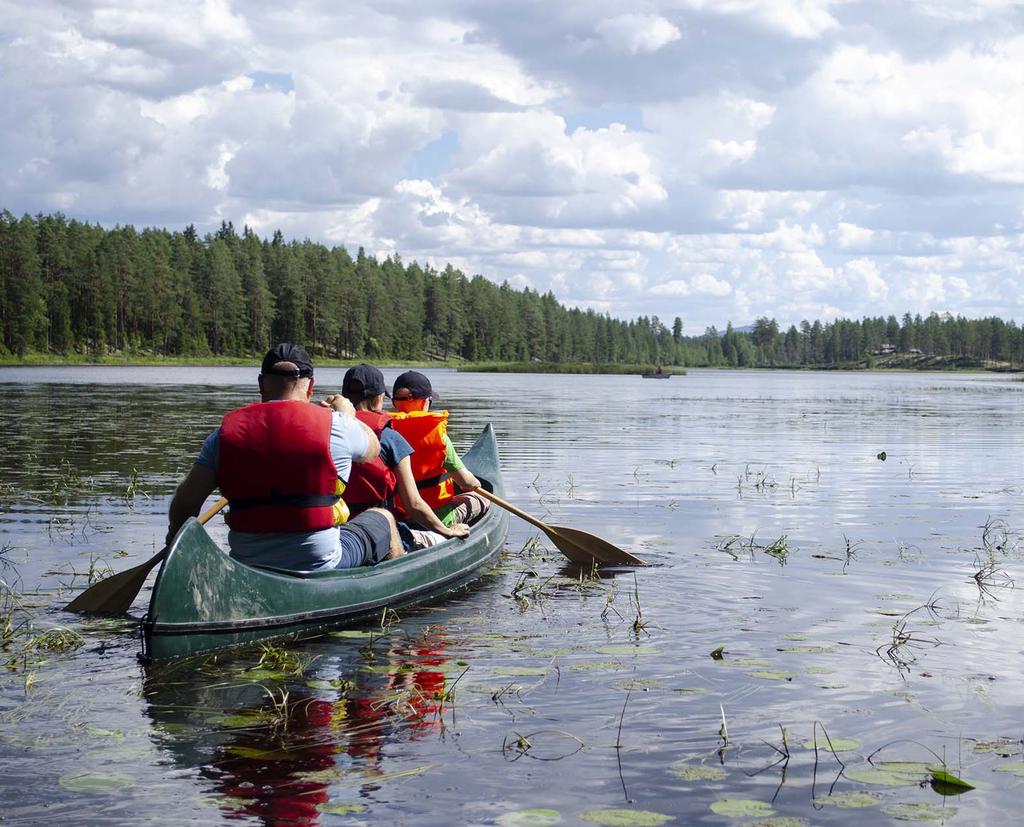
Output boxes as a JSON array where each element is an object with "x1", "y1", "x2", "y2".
[{"x1": 143, "y1": 628, "x2": 449, "y2": 827}]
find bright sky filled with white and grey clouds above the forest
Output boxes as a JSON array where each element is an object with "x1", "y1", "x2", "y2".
[{"x1": 0, "y1": 0, "x2": 1024, "y2": 335}]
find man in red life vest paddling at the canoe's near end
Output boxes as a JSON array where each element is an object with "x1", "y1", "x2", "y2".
[{"x1": 167, "y1": 342, "x2": 403, "y2": 571}]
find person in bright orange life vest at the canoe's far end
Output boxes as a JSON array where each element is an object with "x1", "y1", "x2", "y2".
[{"x1": 391, "y1": 371, "x2": 490, "y2": 525}]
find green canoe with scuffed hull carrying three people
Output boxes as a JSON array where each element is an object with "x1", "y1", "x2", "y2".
[{"x1": 142, "y1": 425, "x2": 509, "y2": 660}]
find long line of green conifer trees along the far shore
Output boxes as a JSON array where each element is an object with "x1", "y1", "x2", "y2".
[{"x1": 0, "y1": 211, "x2": 1024, "y2": 366}]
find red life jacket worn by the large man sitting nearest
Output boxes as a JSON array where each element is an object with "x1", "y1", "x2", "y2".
[{"x1": 217, "y1": 400, "x2": 340, "y2": 534}]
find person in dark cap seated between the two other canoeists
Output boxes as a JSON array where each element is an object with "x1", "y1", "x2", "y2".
[{"x1": 328, "y1": 364, "x2": 469, "y2": 550}]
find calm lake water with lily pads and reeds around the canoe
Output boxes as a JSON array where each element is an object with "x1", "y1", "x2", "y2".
[{"x1": 0, "y1": 367, "x2": 1024, "y2": 825}]
